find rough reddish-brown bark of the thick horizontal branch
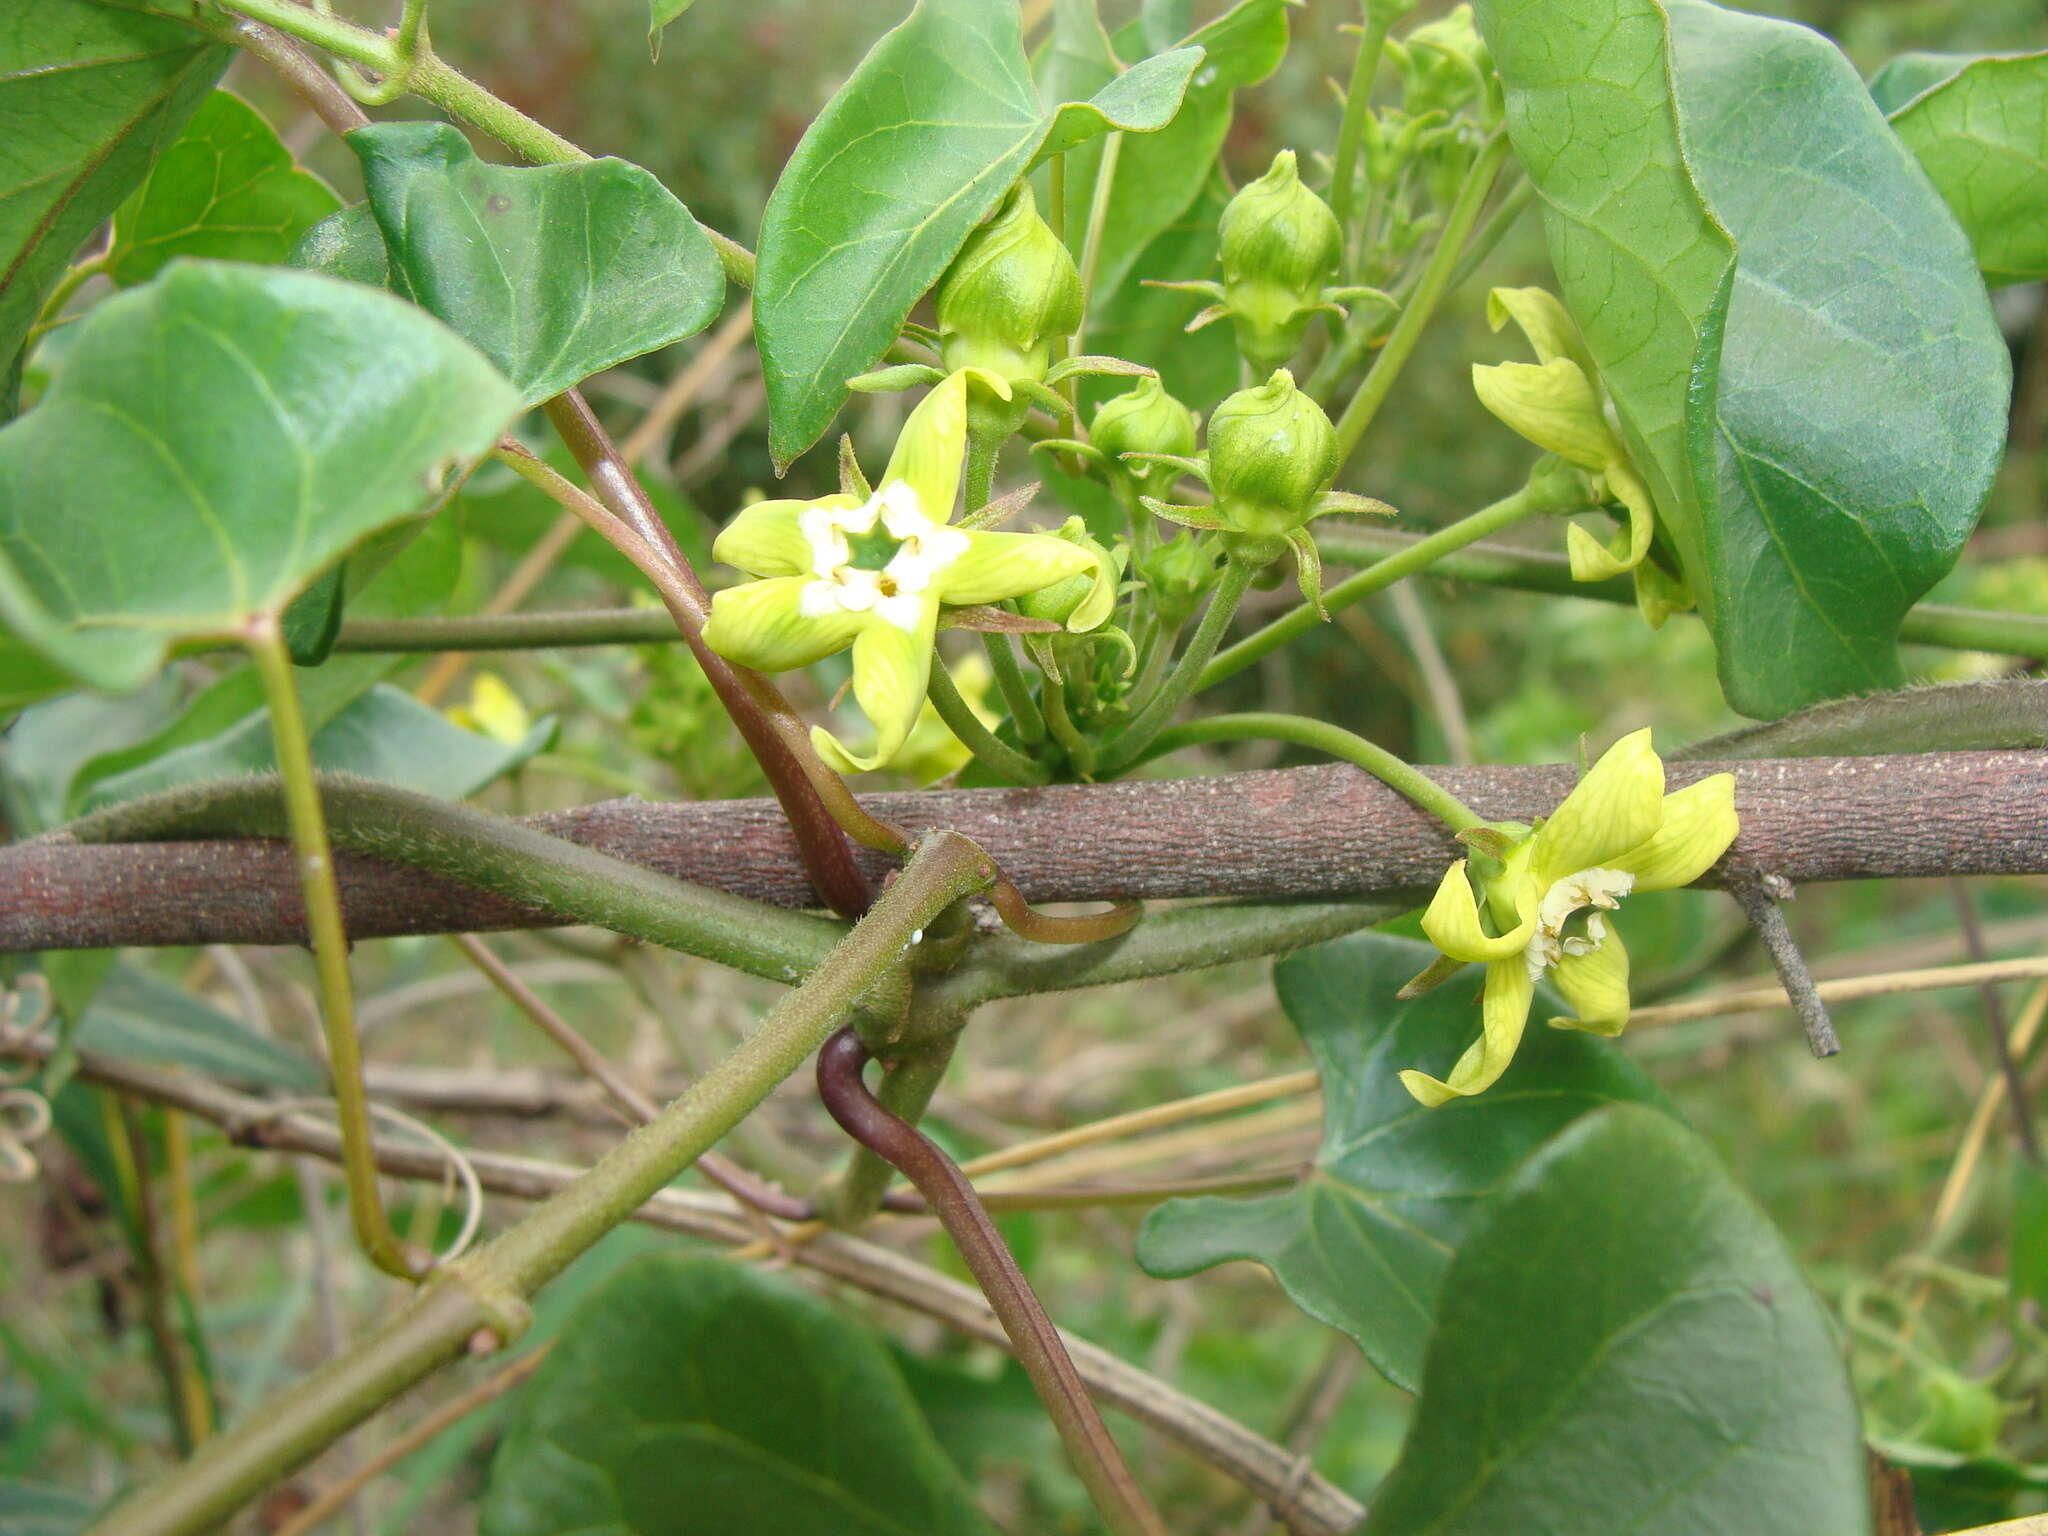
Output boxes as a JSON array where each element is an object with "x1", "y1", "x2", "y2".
[{"x1": 0, "y1": 752, "x2": 2048, "y2": 952}]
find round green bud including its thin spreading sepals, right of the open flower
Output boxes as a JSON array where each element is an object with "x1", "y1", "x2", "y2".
[{"x1": 1128, "y1": 369, "x2": 1393, "y2": 616}]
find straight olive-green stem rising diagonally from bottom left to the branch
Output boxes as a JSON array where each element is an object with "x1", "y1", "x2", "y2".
[{"x1": 94, "y1": 831, "x2": 991, "y2": 1536}]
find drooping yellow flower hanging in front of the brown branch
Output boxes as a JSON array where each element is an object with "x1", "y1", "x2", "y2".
[{"x1": 1401, "y1": 731, "x2": 1737, "y2": 1108}]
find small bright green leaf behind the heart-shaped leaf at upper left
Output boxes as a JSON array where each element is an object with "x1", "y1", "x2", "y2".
[{"x1": 106, "y1": 90, "x2": 340, "y2": 289}]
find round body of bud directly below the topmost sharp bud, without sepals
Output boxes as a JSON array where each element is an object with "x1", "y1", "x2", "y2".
[{"x1": 1208, "y1": 369, "x2": 1337, "y2": 535}]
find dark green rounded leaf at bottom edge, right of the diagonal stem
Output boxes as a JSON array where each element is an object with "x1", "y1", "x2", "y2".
[{"x1": 481, "y1": 1253, "x2": 989, "y2": 1536}]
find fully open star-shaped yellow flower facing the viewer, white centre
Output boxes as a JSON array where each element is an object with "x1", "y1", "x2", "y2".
[{"x1": 705, "y1": 369, "x2": 1094, "y2": 772}]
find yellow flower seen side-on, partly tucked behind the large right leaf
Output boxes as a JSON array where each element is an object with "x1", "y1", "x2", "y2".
[{"x1": 1473, "y1": 289, "x2": 1657, "y2": 582}]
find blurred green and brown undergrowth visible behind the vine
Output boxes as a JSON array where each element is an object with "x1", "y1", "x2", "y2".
[{"x1": 0, "y1": 0, "x2": 2048, "y2": 1534}]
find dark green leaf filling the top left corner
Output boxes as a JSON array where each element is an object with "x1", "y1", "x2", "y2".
[{"x1": 0, "y1": 0, "x2": 233, "y2": 375}]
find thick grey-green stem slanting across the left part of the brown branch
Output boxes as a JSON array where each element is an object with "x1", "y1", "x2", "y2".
[{"x1": 63, "y1": 774, "x2": 844, "y2": 981}]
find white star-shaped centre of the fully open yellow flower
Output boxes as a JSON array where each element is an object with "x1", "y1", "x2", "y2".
[{"x1": 797, "y1": 479, "x2": 967, "y2": 631}]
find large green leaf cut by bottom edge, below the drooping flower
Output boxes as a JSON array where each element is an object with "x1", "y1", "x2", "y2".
[{"x1": 1362, "y1": 1104, "x2": 1870, "y2": 1536}]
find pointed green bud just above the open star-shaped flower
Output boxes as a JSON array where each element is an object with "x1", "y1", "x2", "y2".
[{"x1": 938, "y1": 182, "x2": 1081, "y2": 383}]
